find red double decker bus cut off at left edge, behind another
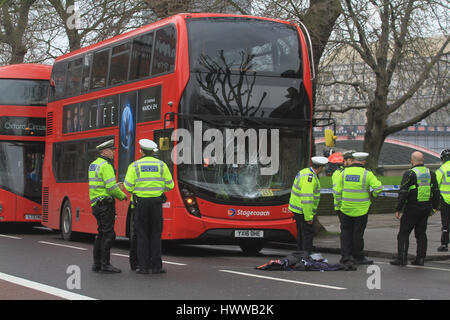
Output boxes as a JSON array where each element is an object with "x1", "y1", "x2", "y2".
[{"x1": 0, "y1": 64, "x2": 52, "y2": 223}]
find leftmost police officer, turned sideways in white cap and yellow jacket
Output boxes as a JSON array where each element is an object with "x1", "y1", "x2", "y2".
[{"x1": 89, "y1": 139, "x2": 127, "y2": 273}]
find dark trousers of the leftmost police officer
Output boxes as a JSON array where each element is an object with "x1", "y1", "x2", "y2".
[{"x1": 92, "y1": 203, "x2": 116, "y2": 266}]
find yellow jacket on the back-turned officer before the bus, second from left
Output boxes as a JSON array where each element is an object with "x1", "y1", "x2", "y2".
[{"x1": 124, "y1": 157, "x2": 174, "y2": 198}]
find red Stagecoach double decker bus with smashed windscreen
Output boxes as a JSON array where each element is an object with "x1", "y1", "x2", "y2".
[{"x1": 42, "y1": 14, "x2": 312, "y2": 252}]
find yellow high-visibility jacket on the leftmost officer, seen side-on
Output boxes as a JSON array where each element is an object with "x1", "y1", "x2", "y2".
[{"x1": 89, "y1": 157, "x2": 127, "y2": 207}]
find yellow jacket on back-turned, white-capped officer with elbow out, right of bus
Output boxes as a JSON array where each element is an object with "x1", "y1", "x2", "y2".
[{"x1": 334, "y1": 164, "x2": 383, "y2": 217}]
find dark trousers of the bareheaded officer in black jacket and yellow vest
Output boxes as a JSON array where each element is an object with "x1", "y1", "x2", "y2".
[{"x1": 397, "y1": 205, "x2": 431, "y2": 261}]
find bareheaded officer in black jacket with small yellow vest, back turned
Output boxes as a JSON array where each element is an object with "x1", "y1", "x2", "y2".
[{"x1": 391, "y1": 151, "x2": 439, "y2": 266}]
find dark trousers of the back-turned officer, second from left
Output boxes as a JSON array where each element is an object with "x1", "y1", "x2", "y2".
[{"x1": 134, "y1": 197, "x2": 163, "y2": 270}]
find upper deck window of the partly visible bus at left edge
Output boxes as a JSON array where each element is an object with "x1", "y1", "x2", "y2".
[{"x1": 0, "y1": 79, "x2": 49, "y2": 106}]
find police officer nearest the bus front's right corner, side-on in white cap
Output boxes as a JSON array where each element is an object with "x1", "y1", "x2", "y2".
[{"x1": 289, "y1": 157, "x2": 328, "y2": 254}]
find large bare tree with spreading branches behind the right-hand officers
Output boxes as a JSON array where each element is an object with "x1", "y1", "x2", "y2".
[{"x1": 322, "y1": 0, "x2": 450, "y2": 169}]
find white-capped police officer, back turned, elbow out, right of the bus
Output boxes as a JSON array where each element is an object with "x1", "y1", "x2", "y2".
[{"x1": 334, "y1": 152, "x2": 383, "y2": 268}]
